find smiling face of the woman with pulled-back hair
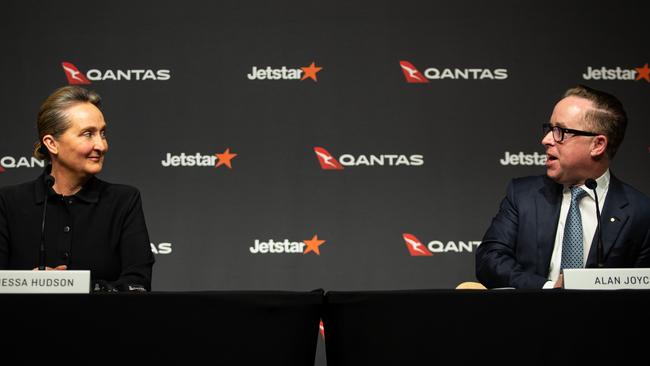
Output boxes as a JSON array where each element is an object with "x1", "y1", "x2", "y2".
[{"x1": 53, "y1": 103, "x2": 108, "y2": 176}]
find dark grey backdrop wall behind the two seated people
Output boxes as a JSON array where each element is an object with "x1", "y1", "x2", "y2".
[{"x1": 0, "y1": 0, "x2": 650, "y2": 364}]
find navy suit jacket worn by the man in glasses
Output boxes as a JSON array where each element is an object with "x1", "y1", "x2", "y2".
[{"x1": 476, "y1": 175, "x2": 650, "y2": 289}]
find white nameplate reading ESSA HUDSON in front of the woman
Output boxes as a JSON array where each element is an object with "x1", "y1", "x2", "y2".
[{"x1": 0, "y1": 271, "x2": 90, "y2": 294}]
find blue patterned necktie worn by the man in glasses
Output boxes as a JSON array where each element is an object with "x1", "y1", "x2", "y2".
[{"x1": 561, "y1": 187, "x2": 587, "y2": 269}]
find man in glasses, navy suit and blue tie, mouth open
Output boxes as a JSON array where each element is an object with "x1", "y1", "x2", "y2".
[{"x1": 476, "y1": 86, "x2": 650, "y2": 289}]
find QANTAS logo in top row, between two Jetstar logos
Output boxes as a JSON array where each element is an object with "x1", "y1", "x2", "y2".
[{"x1": 399, "y1": 60, "x2": 508, "y2": 84}]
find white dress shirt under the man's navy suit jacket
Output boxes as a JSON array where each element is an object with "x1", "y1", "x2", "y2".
[{"x1": 544, "y1": 169, "x2": 610, "y2": 288}]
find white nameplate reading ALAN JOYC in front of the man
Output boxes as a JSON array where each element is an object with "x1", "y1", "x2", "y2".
[{"x1": 564, "y1": 268, "x2": 650, "y2": 290}]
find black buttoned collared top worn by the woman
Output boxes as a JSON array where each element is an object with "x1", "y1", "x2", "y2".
[{"x1": 0, "y1": 166, "x2": 154, "y2": 290}]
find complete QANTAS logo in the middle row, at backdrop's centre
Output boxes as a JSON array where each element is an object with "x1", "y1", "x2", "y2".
[{"x1": 314, "y1": 146, "x2": 424, "y2": 170}]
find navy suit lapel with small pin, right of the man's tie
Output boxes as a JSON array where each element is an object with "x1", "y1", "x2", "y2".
[{"x1": 587, "y1": 175, "x2": 629, "y2": 267}]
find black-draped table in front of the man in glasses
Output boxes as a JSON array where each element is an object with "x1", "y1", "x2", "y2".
[{"x1": 323, "y1": 290, "x2": 650, "y2": 366}]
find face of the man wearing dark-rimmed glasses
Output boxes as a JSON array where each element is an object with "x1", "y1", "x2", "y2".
[{"x1": 542, "y1": 96, "x2": 594, "y2": 185}]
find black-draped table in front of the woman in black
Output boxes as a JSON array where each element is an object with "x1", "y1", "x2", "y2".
[{"x1": 0, "y1": 290, "x2": 323, "y2": 366}]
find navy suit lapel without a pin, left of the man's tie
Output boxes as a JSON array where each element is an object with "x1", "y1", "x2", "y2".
[{"x1": 535, "y1": 177, "x2": 562, "y2": 276}]
